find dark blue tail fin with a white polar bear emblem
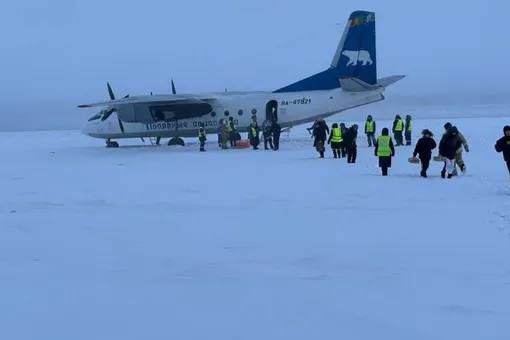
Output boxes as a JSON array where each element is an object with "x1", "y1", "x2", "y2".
[{"x1": 273, "y1": 11, "x2": 377, "y2": 92}]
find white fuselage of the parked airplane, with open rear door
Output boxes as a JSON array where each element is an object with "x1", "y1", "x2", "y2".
[{"x1": 82, "y1": 88, "x2": 384, "y2": 139}]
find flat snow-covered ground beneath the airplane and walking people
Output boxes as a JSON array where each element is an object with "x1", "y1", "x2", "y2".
[{"x1": 0, "y1": 115, "x2": 510, "y2": 340}]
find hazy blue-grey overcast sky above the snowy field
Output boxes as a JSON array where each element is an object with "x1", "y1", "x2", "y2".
[{"x1": 0, "y1": 0, "x2": 510, "y2": 130}]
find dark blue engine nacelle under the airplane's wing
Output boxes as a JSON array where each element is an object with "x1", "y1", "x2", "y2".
[{"x1": 115, "y1": 102, "x2": 212, "y2": 124}]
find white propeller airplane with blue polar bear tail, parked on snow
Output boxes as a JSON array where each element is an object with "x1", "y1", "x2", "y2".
[{"x1": 78, "y1": 10, "x2": 405, "y2": 147}]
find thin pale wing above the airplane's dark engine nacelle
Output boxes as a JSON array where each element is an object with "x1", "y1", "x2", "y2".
[{"x1": 78, "y1": 94, "x2": 216, "y2": 108}]
